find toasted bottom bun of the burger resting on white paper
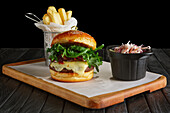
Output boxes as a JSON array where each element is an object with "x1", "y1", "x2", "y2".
[{"x1": 50, "y1": 69, "x2": 94, "y2": 82}]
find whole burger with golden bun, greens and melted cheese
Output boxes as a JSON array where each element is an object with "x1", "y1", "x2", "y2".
[{"x1": 47, "y1": 30, "x2": 104, "y2": 82}]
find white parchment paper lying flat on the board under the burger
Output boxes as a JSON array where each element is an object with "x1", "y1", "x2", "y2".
[{"x1": 9, "y1": 62, "x2": 161, "y2": 97}]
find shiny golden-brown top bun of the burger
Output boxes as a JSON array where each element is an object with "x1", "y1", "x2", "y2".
[{"x1": 51, "y1": 30, "x2": 96, "y2": 50}]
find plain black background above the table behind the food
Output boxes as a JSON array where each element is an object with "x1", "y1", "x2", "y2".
[{"x1": 1, "y1": 0, "x2": 170, "y2": 48}]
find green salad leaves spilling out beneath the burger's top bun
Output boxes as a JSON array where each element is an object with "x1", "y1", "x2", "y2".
[{"x1": 47, "y1": 44, "x2": 104, "y2": 72}]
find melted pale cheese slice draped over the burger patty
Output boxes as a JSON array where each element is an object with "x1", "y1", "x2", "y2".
[{"x1": 50, "y1": 61, "x2": 88, "y2": 75}]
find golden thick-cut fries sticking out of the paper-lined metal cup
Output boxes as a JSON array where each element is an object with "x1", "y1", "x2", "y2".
[{"x1": 43, "y1": 6, "x2": 72, "y2": 25}]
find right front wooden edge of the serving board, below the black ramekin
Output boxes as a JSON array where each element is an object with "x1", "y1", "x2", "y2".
[{"x1": 90, "y1": 75, "x2": 167, "y2": 109}]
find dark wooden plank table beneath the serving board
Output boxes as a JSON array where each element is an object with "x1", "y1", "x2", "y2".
[{"x1": 0, "y1": 48, "x2": 170, "y2": 113}]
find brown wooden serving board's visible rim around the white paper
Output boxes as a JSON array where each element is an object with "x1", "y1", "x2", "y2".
[{"x1": 2, "y1": 58, "x2": 167, "y2": 109}]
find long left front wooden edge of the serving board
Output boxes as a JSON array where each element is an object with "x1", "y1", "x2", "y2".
[{"x1": 2, "y1": 63, "x2": 91, "y2": 108}]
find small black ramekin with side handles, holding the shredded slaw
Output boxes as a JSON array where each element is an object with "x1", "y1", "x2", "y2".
[{"x1": 106, "y1": 45, "x2": 153, "y2": 81}]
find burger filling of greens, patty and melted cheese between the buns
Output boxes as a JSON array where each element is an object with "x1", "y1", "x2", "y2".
[{"x1": 47, "y1": 44, "x2": 104, "y2": 75}]
